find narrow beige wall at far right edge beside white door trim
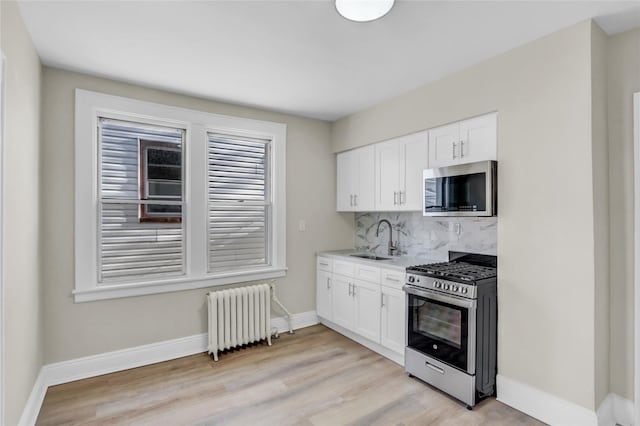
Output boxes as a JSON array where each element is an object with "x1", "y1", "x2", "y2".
[{"x1": 607, "y1": 25, "x2": 640, "y2": 400}]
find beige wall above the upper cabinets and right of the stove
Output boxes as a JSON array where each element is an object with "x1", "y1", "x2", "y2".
[{"x1": 332, "y1": 22, "x2": 608, "y2": 410}]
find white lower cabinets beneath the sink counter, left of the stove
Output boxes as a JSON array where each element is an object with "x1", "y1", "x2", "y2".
[{"x1": 316, "y1": 258, "x2": 406, "y2": 363}]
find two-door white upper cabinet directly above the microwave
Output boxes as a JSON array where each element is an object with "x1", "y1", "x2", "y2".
[{"x1": 429, "y1": 113, "x2": 497, "y2": 168}]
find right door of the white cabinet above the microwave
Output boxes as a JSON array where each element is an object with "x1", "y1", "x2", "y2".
[{"x1": 459, "y1": 113, "x2": 497, "y2": 163}]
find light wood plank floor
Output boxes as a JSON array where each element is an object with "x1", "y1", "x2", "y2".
[{"x1": 37, "y1": 325, "x2": 541, "y2": 426}]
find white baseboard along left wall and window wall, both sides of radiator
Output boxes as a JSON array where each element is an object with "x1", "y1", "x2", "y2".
[{"x1": 20, "y1": 311, "x2": 318, "y2": 426}]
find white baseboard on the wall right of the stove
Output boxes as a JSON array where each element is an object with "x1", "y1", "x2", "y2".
[{"x1": 496, "y1": 374, "x2": 598, "y2": 426}]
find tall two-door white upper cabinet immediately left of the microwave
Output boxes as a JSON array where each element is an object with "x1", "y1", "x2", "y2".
[{"x1": 375, "y1": 132, "x2": 429, "y2": 211}]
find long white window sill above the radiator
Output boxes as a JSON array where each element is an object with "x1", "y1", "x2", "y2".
[{"x1": 73, "y1": 268, "x2": 287, "y2": 303}]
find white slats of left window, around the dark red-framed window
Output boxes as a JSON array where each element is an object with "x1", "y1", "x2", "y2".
[{"x1": 98, "y1": 119, "x2": 185, "y2": 284}]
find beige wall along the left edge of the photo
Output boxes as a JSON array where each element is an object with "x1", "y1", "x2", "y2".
[{"x1": 0, "y1": 1, "x2": 43, "y2": 425}]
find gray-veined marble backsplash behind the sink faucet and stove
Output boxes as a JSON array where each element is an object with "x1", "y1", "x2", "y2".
[{"x1": 354, "y1": 212, "x2": 497, "y2": 260}]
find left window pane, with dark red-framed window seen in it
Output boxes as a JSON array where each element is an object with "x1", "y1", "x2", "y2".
[{"x1": 98, "y1": 117, "x2": 185, "y2": 283}]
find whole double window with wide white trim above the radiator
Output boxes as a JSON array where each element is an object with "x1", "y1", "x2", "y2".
[{"x1": 74, "y1": 90, "x2": 286, "y2": 302}]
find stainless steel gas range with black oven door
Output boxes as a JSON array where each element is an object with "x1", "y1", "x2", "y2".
[{"x1": 404, "y1": 252, "x2": 498, "y2": 409}]
